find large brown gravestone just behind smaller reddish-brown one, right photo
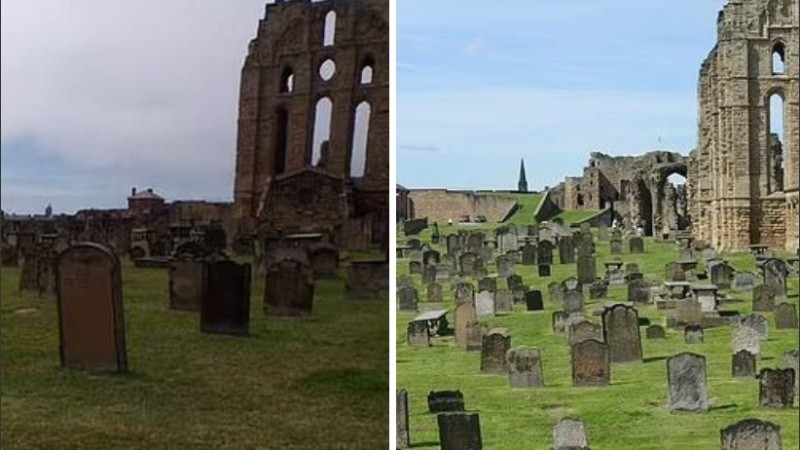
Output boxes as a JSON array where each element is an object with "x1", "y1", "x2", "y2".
[{"x1": 601, "y1": 304, "x2": 642, "y2": 362}]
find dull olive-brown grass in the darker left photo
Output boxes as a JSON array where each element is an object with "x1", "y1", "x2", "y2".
[{"x1": 0, "y1": 261, "x2": 389, "y2": 449}]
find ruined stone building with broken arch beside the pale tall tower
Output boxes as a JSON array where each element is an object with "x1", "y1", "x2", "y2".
[{"x1": 551, "y1": 151, "x2": 689, "y2": 235}]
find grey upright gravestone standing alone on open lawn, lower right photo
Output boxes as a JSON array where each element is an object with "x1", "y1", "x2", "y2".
[{"x1": 667, "y1": 353, "x2": 708, "y2": 412}]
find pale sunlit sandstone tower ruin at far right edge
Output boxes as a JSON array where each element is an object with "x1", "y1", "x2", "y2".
[{"x1": 688, "y1": 0, "x2": 800, "y2": 250}]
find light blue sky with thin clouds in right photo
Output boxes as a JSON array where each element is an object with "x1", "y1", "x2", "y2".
[{"x1": 397, "y1": 0, "x2": 725, "y2": 189}]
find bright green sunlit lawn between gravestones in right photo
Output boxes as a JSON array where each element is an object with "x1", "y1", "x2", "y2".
[{"x1": 396, "y1": 234, "x2": 800, "y2": 450}]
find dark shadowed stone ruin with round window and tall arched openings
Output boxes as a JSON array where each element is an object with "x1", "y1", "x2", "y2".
[{"x1": 234, "y1": 0, "x2": 389, "y2": 239}]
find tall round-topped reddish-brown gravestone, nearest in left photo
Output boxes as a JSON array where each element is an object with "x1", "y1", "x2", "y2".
[{"x1": 56, "y1": 243, "x2": 128, "y2": 372}]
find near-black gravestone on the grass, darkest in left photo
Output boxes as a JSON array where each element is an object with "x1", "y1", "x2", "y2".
[{"x1": 200, "y1": 260, "x2": 251, "y2": 336}]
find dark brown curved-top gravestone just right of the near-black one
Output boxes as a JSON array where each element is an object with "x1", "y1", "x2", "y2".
[{"x1": 264, "y1": 259, "x2": 312, "y2": 316}]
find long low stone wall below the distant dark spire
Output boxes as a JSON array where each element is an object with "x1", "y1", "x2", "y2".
[{"x1": 408, "y1": 189, "x2": 517, "y2": 223}]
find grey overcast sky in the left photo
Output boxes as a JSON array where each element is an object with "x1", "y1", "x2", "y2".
[{"x1": 0, "y1": 0, "x2": 267, "y2": 213}]
